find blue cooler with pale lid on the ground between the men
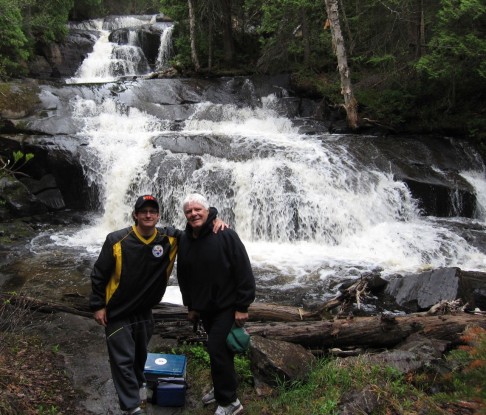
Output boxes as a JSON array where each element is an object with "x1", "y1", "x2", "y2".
[{"x1": 144, "y1": 353, "x2": 187, "y2": 406}]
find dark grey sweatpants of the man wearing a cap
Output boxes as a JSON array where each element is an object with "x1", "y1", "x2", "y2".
[{"x1": 105, "y1": 310, "x2": 154, "y2": 411}]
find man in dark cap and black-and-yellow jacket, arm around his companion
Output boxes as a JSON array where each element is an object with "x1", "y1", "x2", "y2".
[{"x1": 90, "y1": 195, "x2": 221, "y2": 415}]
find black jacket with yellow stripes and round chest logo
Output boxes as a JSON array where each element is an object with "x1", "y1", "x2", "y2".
[{"x1": 90, "y1": 226, "x2": 180, "y2": 320}]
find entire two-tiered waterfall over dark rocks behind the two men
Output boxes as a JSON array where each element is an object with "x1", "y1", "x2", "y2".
[{"x1": 51, "y1": 16, "x2": 486, "y2": 298}]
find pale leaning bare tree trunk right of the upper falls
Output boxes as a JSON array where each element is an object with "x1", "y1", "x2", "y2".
[{"x1": 325, "y1": 0, "x2": 358, "y2": 129}]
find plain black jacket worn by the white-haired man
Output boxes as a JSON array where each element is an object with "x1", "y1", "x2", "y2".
[{"x1": 177, "y1": 211, "x2": 255, "y2": 312}]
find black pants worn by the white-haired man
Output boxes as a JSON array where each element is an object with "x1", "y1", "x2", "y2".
[{"x1": 201, "y1": 309, "x2": 237, "y2": 406}]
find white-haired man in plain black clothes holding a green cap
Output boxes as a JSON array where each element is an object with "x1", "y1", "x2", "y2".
[{"x1": 177, "y1": 193, "x2": 255, "y2": 415}]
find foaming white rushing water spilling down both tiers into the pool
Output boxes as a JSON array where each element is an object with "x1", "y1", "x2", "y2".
[{"x1": 13, "y1": 16, "x2": 486, "y2": 308}]
